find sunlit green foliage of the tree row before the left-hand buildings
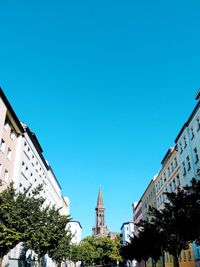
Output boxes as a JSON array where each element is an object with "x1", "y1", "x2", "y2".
[{"x1": 0, "y1": 184, "x2": 70, "y2": 266}]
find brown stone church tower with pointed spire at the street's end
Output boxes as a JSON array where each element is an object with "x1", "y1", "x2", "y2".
[{"x1": 92, "y1": 188, "x2": 109, "y2": 236}]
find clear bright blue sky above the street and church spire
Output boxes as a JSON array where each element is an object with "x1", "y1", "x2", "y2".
[{"x1": 0, "y1": 0, "x2": 200, "y2": 237}]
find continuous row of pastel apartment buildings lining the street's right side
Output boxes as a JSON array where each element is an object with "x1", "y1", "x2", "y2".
[{"x1": 133, "y1": 91, "x2": 200, "y2": 267}]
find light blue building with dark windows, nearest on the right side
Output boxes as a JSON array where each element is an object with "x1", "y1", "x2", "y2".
[{"x1": 175, "y1": 90, "x2": 200, "y2": 267}]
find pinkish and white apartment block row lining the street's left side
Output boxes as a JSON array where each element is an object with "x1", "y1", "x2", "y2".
[{"x1": 0, "y1": 89, "x2": 70, "y2": 267}]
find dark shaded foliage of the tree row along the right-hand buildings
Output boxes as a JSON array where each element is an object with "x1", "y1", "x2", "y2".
[{"x1": 121, "y1": 179, "x2": 200, "y2": 266}]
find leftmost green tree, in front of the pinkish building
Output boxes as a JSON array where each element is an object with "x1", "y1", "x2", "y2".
[{"x1": 0, "y1": 184, "x2": 44, "y2": 266}]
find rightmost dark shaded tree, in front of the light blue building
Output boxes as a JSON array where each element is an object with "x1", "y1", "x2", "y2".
[{"x1": 150, "y1": 179, "x2": 200, "y2": 266}]
